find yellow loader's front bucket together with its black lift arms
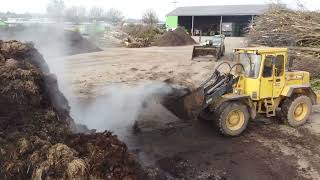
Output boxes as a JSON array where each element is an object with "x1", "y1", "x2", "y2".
[{"x1": 162, "y1": 69, "x2": 229, "y2": 120}]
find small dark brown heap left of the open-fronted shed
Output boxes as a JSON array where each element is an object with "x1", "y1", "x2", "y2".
[{"x1": 154, "y1": 28, "x2": 196, "y2": 46}]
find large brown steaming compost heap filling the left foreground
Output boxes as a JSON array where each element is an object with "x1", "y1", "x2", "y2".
[{"x1": 0, "y1": 41, "x2": 145, "y2": 179}]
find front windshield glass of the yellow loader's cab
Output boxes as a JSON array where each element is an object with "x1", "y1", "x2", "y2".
[{"x1": 237, "y1": 53, "x2": 261, "y2": 79}]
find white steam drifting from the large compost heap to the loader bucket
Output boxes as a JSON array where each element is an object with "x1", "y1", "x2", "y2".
[{"x1": 0, "y1": 25, "x2": 178, "y2": 136}]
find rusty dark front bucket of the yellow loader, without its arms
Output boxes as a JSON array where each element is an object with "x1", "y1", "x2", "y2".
[{"x1": 162, "y1": 85, "x2": 204, "y2": 120}]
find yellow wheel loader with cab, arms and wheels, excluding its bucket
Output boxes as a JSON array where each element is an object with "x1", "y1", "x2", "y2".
[{"x1": 165, "y1": 47, "x2": 319, "y2": 136}]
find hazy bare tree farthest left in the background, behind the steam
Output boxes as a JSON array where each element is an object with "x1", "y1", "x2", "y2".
[{"x1": 47, "y1": 0, "x2": 65, "y2": 21}]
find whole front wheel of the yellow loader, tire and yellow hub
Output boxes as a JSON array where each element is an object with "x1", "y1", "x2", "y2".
[{"x1": 215, "y1": 102, "x2": 249, "y2": 136}]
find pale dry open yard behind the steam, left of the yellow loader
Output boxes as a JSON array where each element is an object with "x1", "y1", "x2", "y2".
[{"x1": 53, "y1": 46, "x2": 214, "y2": 97}]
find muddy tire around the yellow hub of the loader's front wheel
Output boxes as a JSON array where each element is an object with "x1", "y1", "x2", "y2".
[{"x1": 215, "y1": 102, "x2": 250, "y2": 136}]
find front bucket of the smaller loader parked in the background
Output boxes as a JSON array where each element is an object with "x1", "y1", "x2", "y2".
[{"x1": 192, "y1": 46, "x2": 220, "y2": 60}]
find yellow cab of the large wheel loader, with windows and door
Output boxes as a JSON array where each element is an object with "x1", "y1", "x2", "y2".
[{"x1": 234, "y1": 48, "x2": 288, "y2": 100}]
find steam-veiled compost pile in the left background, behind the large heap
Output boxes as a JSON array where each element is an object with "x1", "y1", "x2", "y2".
[{"x1": 0, "y1": 25, "x2": 102, "y2": 57}]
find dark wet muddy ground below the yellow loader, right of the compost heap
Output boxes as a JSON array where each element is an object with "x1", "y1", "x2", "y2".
[{"x1": 125, "y1": 107, "x2": 320, "y2": 180}]
